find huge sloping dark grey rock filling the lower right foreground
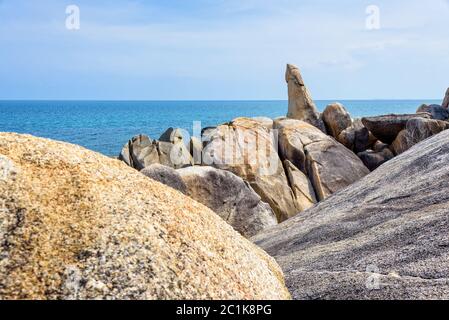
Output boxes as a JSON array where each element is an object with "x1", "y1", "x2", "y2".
[{"x1": 253, "y1": 131, "x2": 449, "y2": 300}]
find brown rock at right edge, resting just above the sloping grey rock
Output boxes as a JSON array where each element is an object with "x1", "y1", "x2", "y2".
[{"x1": 391, "y1": 118, "x2": 449, "y2": 155}]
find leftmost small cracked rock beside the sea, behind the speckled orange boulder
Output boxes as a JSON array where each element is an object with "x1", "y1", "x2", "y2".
[{"x1": 119, "y1": 134, "x2": 158, "y2": 170}]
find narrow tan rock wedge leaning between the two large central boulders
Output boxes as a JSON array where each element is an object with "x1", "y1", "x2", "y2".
[{"x1": 284, "y1": 160, "x2": 317, "y2": 212}]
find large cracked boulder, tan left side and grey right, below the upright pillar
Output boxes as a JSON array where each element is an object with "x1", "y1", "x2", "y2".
[{"x1": 274, "y1": 119, "x2": 369, "y2": 201}]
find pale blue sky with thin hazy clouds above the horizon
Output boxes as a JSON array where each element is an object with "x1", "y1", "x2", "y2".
[{"x1": 0, "y1": 0, "x2": 449, "y2": 100}]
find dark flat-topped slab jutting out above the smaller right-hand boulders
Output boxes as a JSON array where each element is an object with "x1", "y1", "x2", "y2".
[{"x1": 362, "y1": 113, "x2": 430, "y2": 144}]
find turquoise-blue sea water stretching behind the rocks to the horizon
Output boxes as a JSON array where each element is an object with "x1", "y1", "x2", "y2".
[{"x1": 0, "y1": 99, "x2": 441, "y2": 156}]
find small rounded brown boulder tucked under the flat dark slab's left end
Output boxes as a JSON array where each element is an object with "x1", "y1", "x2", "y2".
[{"x1": 337, "y1": 119, "x2": 377, "y2": 153}]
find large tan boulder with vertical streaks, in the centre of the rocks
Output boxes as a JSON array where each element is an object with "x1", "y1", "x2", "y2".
[{"x1": 203, "y1": 118, "x2": 299, "y2": 222}]
